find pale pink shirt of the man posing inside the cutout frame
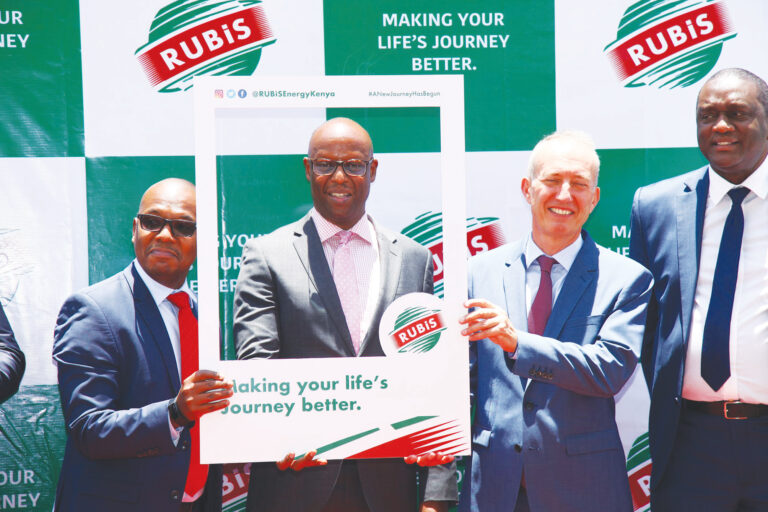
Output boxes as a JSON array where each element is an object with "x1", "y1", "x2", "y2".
[{"x1": 310, "y1": 208, "x2": 381, "y2": 349}]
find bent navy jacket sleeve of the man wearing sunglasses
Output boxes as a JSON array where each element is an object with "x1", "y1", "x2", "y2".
[{"x1": 53, "y1": 294, "x2": 181, "y2": 459}]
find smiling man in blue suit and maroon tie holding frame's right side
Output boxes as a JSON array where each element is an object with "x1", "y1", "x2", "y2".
[{"x1": 459, "y1": 132, "x2": 653, "y2": 512}]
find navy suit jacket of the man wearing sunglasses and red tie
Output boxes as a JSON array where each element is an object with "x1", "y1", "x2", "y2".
[{"x1": 53, "y1": 264, "x2": 221, "y2": 512}]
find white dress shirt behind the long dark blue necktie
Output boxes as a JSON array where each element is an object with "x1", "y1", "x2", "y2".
[{"x1": 683, "y1": 160, "x2": 768, "y2": 404}]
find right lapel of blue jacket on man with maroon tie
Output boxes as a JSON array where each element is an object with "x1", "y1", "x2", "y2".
[{"x1": 544, "y1": 231, "x2": 599, "y2": 338}]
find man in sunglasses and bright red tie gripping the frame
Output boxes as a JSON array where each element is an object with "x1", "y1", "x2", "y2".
[{"x1": 53, "y1": 178, "x2": 232, "y2": 512}]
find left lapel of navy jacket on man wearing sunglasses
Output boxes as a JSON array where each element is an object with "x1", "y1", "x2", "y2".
[{"x1": 123, "y1": 264, "x2": 181, "y2": 393}]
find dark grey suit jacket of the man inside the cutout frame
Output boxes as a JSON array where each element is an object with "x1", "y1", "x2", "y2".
[{"x1": 234, "y1": 216, "x2": 456, "y2": 512}]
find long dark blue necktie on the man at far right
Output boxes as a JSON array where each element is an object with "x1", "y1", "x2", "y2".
[{"x1": 701, "y1": 187, "x2": 749, "y2": 391}]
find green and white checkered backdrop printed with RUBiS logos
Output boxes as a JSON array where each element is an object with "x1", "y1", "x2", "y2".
[{"x1": 0, "y1": 0, "x2": 768, "y2": 510}]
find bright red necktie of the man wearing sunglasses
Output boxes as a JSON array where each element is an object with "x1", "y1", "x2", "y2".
[{"x1": 168, "y1": 292, "x2": 208, "y2": 498}]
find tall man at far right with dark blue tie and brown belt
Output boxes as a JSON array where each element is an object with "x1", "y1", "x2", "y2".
[{"x1": 630, "y1": 69, "x2": 768, "y2": 512}]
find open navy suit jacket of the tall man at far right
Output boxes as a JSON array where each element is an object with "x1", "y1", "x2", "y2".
[{"x1": 629, "y1": 167, "x2": 709, "y2": 490}]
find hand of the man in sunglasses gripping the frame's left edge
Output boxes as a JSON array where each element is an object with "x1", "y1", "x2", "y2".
[{"x1": 172, "y1": 370, "x2": 234, "y2": 428}]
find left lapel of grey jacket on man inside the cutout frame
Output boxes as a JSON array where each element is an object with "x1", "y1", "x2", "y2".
[{"x1": 293, "y1": 215, "x2": 355, "y2": 355}]
